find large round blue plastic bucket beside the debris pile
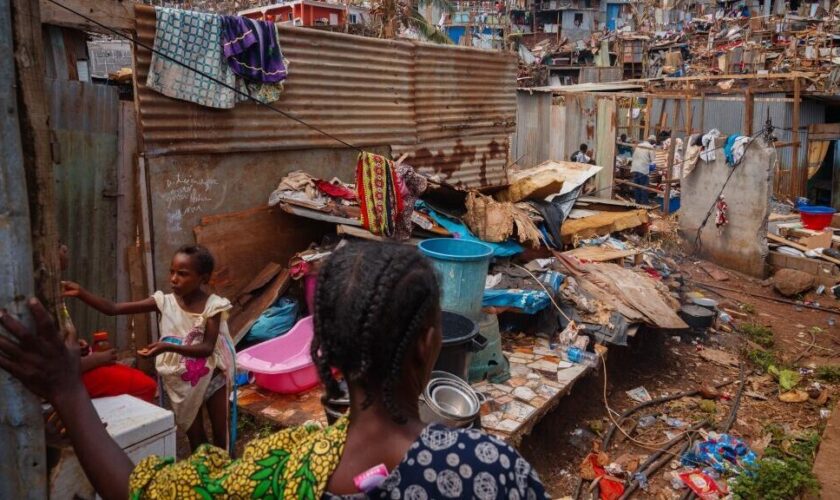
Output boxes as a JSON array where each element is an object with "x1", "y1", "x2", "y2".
[{"x1": 417, "y1": 238, "x2": 493, "y2": 321}]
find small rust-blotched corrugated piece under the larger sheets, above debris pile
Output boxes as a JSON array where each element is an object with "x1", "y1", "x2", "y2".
[{"x1": 391, "y1": 135, "x2": 509, "y2": 188}]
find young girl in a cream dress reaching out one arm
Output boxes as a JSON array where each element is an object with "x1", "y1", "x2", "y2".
[{"x1": 62, "y1": 245, "x2": 235, "y2": 450}]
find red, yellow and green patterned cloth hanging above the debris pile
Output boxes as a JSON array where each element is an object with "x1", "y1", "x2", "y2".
[{"x1": 356, "y1": 153, "x2": 403, "y2": 238}]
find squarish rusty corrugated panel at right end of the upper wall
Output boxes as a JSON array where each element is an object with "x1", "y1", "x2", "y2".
[{"x1": 414, "y1": 43, "x2": 517, "y2": 144}]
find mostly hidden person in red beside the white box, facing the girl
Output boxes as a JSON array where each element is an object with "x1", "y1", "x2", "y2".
[{"x1": 58, "y1": 244, "x2": 157, "y2": 403}]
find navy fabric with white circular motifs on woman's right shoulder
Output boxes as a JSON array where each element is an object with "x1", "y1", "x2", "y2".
[{"x1": 324, "y1": 424, "x2": 549, "y2": 500}]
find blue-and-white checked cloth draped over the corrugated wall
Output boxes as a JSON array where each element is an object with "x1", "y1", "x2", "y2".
[{"x1": 146, "y1": 7, "x2": 236, "y2": 109}]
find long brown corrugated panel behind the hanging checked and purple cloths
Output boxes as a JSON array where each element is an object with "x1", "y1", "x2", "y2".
[{"x1": 135, "y1": 5, "x2": 417, "y2": 156}]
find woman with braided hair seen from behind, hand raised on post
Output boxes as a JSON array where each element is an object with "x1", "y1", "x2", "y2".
[{"x1": 0, "y1": 243, "x2": 546, "y2": 500}]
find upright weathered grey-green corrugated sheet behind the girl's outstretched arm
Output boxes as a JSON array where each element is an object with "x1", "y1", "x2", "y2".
[{"x1": 46, "y1": 80, "x2": 119, "y2": 345}]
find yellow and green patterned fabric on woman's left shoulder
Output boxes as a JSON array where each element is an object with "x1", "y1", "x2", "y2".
[{"x1": 129, "y1": 418, "x2": 347, "y2": 500}]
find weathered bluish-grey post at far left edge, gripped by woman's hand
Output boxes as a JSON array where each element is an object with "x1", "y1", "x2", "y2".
[{"x1": 0, "y1": 0, "x2": 47, "y2": 499}]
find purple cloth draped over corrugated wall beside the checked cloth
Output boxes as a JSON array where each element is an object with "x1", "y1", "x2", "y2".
[{"x1": 221, "y1": 16, "x2": 287, "y2": 83}]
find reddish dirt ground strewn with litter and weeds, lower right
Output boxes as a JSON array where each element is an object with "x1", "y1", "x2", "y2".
[{"x1": 522, "y1": 259, "x2": 840, "y2": 498}]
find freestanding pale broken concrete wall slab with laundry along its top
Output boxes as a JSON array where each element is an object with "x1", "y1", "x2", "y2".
[{"x1": 678, "y1": 138, "x2": 776, "y2": 277}]
